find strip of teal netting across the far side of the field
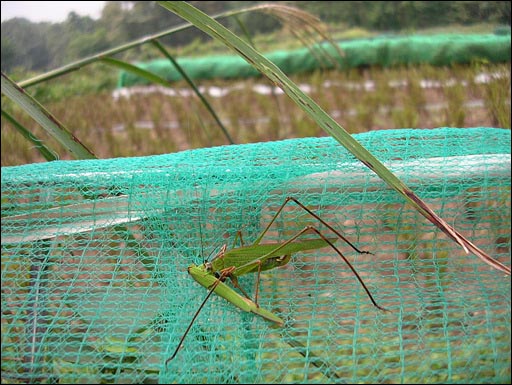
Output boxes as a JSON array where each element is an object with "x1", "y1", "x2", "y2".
[{"x1": 118, "y1": 33, "x2": 510, "y2": 87}]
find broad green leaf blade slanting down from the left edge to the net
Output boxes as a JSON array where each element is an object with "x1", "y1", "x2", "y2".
[{"x1": 2, "y1": 72, "x2": 96, "y2": 159}]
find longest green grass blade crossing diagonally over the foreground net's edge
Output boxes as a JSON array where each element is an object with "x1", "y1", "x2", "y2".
[{"x1": 158, "y1": 1, "x2": 510, "y2": 275}]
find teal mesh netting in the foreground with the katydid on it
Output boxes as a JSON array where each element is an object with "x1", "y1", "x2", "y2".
[{"x1": 2, "y1": 128, "x2": 511, "y2": 383}]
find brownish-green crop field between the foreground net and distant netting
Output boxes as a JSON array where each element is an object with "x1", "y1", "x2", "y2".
[{"x1": 2, "y1": 63, "x2": 511, "y2": 166}]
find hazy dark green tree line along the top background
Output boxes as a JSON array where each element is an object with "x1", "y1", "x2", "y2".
[{"x1": 1, "y1": 1, "x2": 511, "y2": 72}]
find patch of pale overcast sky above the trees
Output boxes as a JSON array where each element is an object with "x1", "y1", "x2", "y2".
[{"x1": 2, "y1": 1, "x2": 105, "y2": 23}]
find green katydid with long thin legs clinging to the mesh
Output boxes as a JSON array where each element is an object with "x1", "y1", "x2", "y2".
[{"x1": 165, "y1": 197, "x2": 386, "y2": 365}]
